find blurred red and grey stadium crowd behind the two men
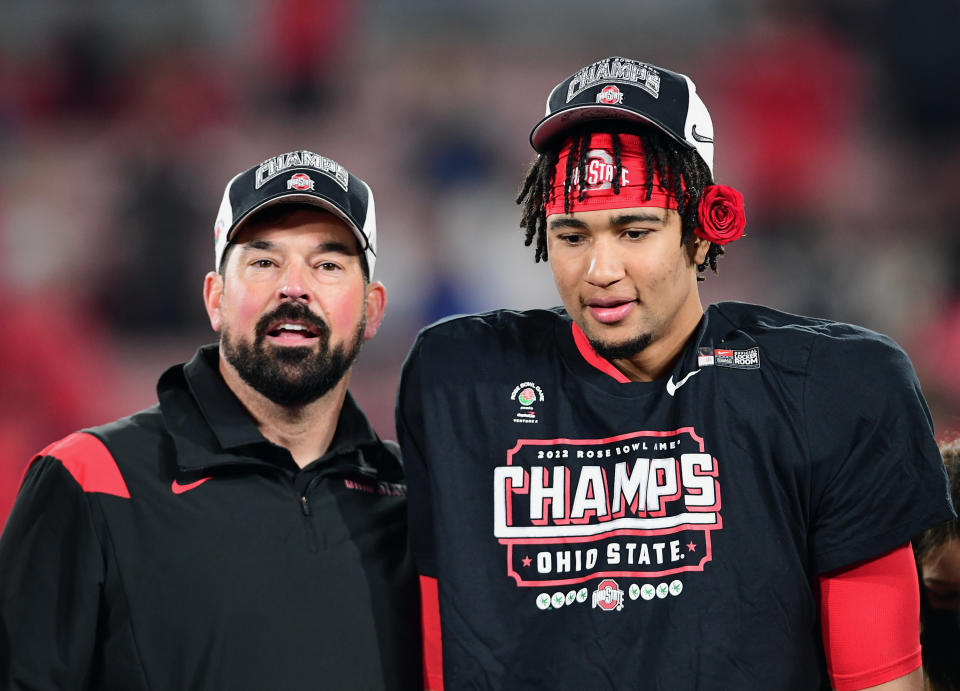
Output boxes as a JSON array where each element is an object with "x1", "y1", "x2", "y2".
[{"x1": 0, "y1": 0, "x2": 960, "y2": 523}]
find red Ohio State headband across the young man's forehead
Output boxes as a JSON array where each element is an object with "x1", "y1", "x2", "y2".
[{"x1": 546, "y1": 133, "x2": 679, "y2": 216}]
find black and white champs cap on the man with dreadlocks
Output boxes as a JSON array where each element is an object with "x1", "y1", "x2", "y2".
[{"x1": 530, "y1": 57, "x2": 713, "y2": 175}]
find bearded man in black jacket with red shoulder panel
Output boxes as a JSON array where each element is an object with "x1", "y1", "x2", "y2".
[{"x1": 0, "y1": 150, "x2": 420, "y2": 691}]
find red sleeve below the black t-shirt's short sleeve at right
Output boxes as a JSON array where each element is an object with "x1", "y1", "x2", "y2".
[{"x1": 820, "y1": 543, "x2": 920, "y2": 691}]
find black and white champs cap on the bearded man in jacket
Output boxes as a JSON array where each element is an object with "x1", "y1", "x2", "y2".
[{"x1": 214, "y1": 149, "x2": 377, "y2": 278}]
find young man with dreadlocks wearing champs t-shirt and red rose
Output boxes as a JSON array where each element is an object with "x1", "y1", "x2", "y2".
[{"x1": 397, "y1": 58, "x2": 952, "y2": 690}]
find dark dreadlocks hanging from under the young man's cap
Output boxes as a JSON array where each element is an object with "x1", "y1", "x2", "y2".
[{"x1": 517, "y1": 121, "x2": 724, "y2": 281}]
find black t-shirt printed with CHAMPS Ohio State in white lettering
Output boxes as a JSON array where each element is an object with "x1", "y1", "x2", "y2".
[{"x1": 397, "y1": 303, "x2": 952, "y2": 690}]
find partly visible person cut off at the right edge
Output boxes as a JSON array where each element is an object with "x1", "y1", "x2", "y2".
[{"x1": 913, "y1": 438, "x2": 960, "y2": 691}]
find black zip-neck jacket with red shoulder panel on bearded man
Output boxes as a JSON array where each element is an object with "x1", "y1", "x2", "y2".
[{"x1": 0, "y1": 346, "x2": 422, "y2": 691}]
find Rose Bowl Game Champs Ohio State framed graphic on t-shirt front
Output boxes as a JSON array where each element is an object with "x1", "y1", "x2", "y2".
[{"x1": 493, "y1": 427, "x2": 723, "y2": 588}]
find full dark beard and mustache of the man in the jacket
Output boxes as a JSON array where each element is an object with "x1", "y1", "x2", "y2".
[{"x1": 220, "y1": 302, "x2": 366, "y2": 408}]
